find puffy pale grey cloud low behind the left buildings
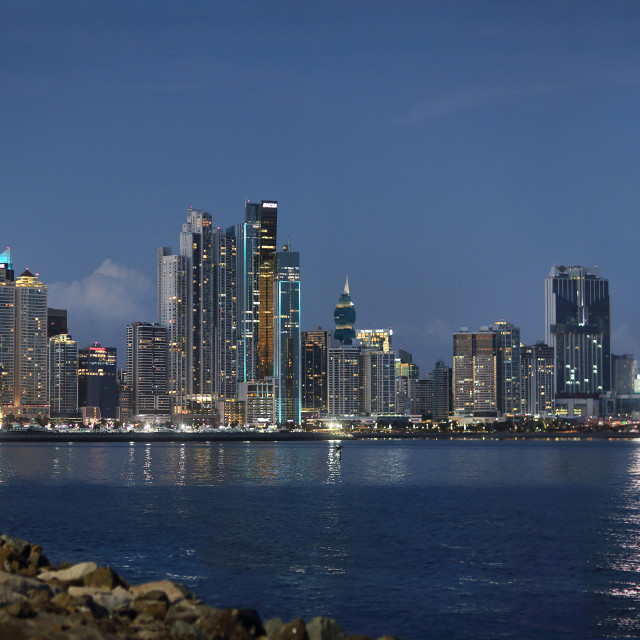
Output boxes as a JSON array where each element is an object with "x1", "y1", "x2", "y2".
[{"x1": 49, "y1": 258, "x2": 155, "y2": 346}]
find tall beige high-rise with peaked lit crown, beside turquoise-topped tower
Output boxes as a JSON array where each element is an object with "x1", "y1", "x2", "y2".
[{"x1": 13, "y1": 269, "x2": 49, "y2": 418}]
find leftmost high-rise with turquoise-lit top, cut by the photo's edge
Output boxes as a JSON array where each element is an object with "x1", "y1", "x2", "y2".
[{"x1": 0, "y1": 247, "x2": 16, "y2": 409}]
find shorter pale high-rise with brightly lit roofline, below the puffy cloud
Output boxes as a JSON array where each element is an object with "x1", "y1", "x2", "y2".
[{"x1": 49, "y1": 333, "x2": 78, "y2": 417}]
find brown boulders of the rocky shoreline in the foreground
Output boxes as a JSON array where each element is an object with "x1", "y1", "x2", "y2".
[{"x1": 0, "y1": 534, "x2": 398, "y2": 640}]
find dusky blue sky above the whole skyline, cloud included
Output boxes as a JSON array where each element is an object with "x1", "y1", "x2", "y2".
[{"x1": 0, "y1": 0, "x2": 640, "y2": 372}]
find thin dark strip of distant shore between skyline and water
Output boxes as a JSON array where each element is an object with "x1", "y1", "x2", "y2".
[{"x1": 0, "y1": 431, "x2": 640, "y2": 444}]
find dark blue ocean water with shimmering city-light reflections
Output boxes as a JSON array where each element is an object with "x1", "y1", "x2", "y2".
[{"x1": 0, "y1": 440, "x2": 640, "y2": 640}]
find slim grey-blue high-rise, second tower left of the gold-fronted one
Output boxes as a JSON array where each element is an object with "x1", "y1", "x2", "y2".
[{"x1": 213, "y1": 227, "x2": 238, "y2": 401}]
